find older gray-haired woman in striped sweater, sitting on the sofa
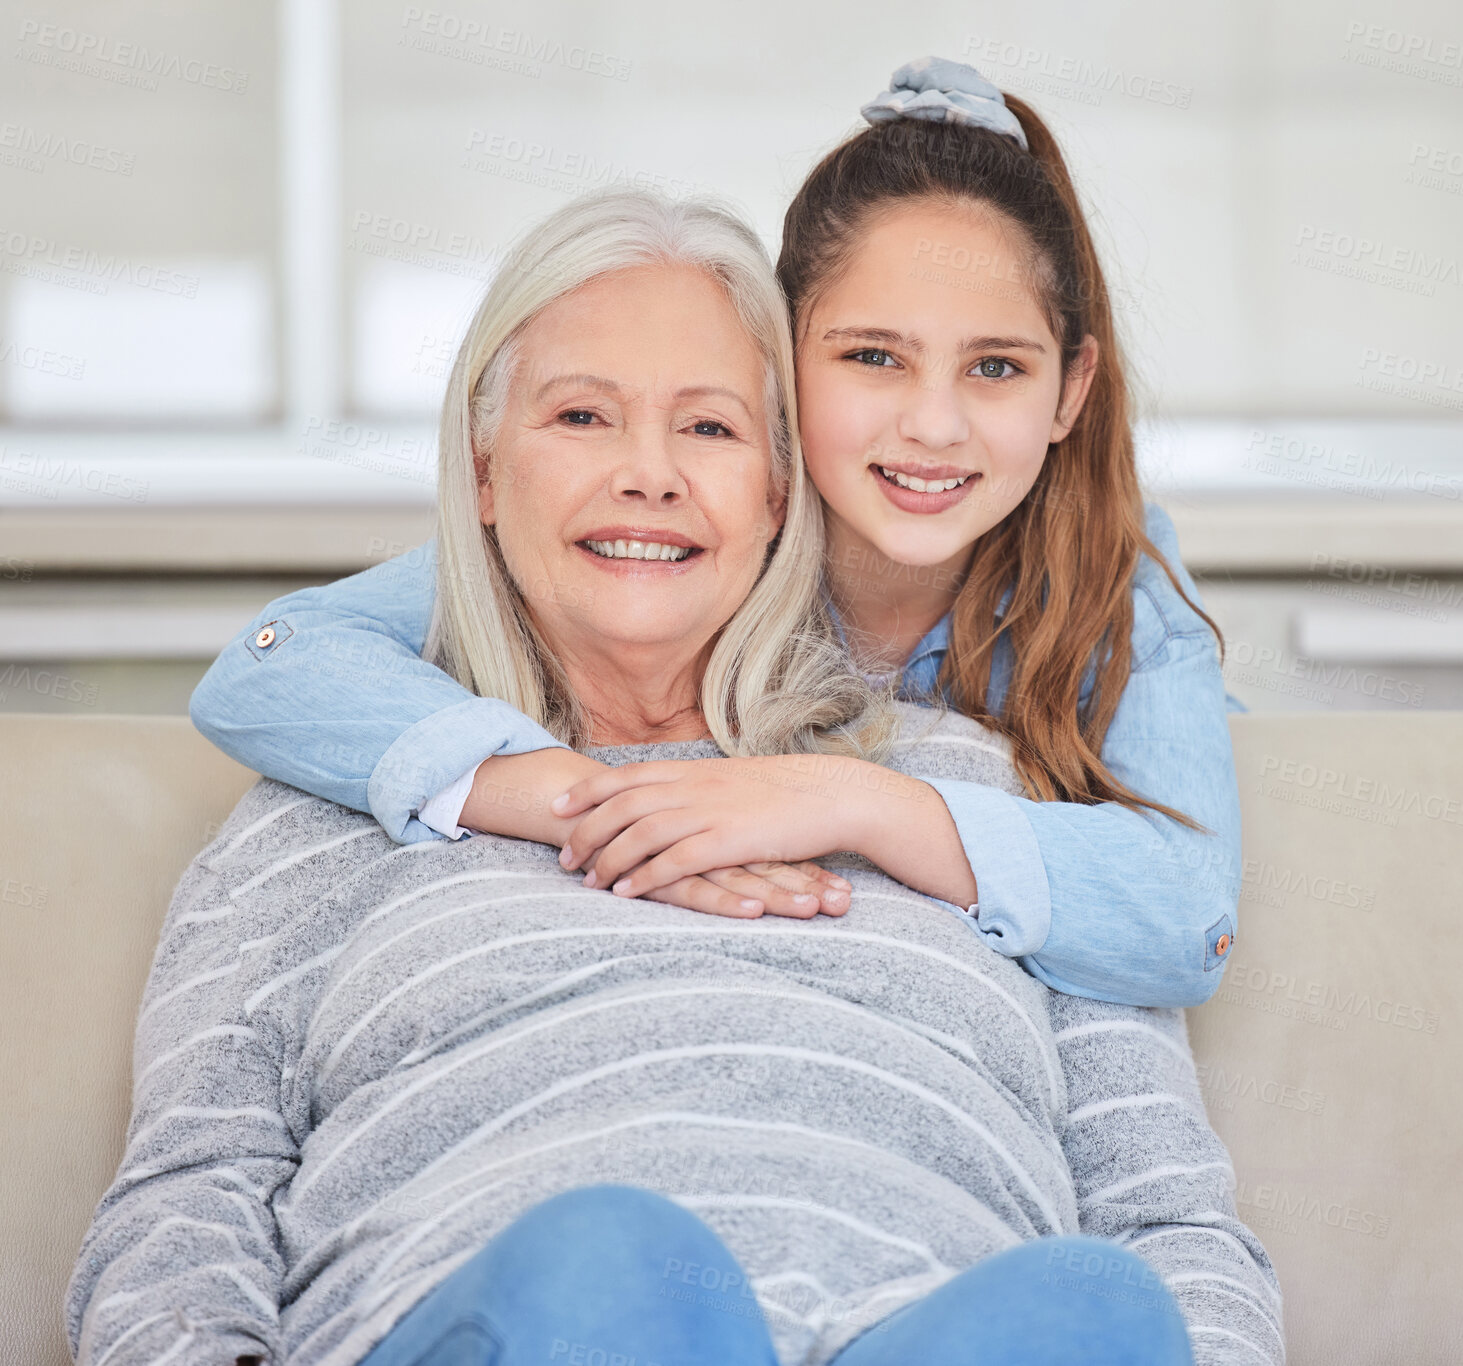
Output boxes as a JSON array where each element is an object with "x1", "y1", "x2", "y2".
[{"x1": 66, "y1": 196, "x2": 1283, "y2": 1366}]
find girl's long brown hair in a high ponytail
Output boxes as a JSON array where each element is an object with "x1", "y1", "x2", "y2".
[{"x1": 777, "y1": 95, "x2": 1223, "y2": 829}]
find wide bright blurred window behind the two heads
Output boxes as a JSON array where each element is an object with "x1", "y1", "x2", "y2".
[{"x1": 0, "y1": 0, "x2": 1463, "y2": 505}]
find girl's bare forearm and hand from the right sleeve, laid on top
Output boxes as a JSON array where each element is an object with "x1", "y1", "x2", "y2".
[{"x1": 549, "y1": 755, "x2": 977, "y2": 905}]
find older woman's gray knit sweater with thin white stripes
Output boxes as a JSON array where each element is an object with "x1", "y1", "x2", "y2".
[{"x1": 66, "y1": 706, "x2": 1285, "y2": 1366}]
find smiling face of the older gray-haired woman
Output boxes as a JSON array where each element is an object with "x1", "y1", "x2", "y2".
[{"x1": 480, "y1": 263, "x2": 781, "y2": 666}]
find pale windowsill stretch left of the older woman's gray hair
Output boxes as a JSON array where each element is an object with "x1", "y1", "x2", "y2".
[{"x1": 0, "y1": 421, "x2": 436, "y2": 576}]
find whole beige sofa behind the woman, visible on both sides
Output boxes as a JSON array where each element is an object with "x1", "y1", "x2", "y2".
[{"x1": 0, "y1": 712, "x2": 1463, "y2": 1366}]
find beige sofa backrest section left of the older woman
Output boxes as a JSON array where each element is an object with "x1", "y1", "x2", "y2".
[{"x1": 0, "y1": 715, "x2": 256, "y2": 1366}]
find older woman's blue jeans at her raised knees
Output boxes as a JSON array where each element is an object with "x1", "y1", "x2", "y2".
[{"x1": 363, "y1": 1185, "x2": 1194, "y2": 1366}]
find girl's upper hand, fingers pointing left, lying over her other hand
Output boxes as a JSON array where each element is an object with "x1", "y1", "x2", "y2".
[{"x1": 550, "y1": 755, "x2": 889, "y2": 897}]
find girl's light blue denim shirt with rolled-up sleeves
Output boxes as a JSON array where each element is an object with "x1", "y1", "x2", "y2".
[{"x1": 189, "y1": 505, "x2": 1244, "y2": 1006}]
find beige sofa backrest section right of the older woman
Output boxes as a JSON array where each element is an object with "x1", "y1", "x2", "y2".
[{"x1": 1188, "y1": 712, "x2": 1463, "y2": 1366}]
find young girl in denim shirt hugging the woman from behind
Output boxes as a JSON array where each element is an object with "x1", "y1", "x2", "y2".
[{"x1": 190, "y1": 59, "x2": 1239, "y2": 1006}]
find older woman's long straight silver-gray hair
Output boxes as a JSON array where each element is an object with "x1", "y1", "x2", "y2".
[{"x1": 424, "y1": 190, "x2": 895, "y2": 762}]
